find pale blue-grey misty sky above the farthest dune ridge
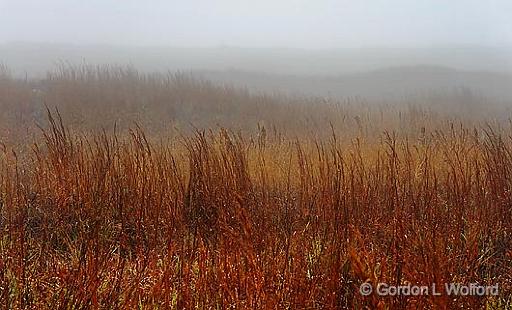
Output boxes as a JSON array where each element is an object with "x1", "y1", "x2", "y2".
[{"x1": 0, "y1": 0, "x2": 512, "y2": 48}]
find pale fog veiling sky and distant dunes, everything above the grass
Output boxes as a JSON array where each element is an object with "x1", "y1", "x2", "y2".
[{"x1": 0, "y1": 0, "x2": 512, "y2": 98}]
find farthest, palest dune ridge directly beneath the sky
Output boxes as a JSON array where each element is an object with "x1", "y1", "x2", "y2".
[{"x1": 0, "y1": 43, "x2": 512, "y2": 76}]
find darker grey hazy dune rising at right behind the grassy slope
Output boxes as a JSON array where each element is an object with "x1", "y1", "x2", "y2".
[{"x1": 196, "y1": 65, "x2": 512, "y2": 100}]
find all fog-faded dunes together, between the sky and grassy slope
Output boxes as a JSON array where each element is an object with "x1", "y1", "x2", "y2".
[{"x1": 0, "y1": 43, "x2": 512, "y2": 100}]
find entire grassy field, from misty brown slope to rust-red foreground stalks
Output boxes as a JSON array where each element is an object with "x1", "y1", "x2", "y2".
[{"x1": 0, "y1": 66, "x2": 512, "y2": 309}]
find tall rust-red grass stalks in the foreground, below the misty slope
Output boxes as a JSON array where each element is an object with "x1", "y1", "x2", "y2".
[{"x1": 0, "y1": 110, "x2": 512, "y2": 309}]
